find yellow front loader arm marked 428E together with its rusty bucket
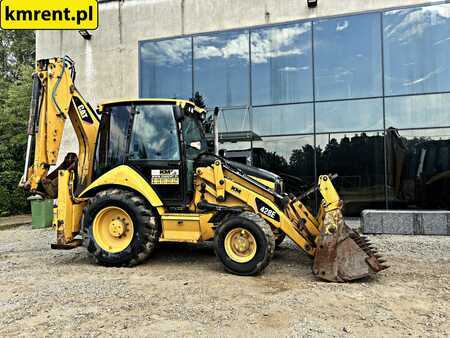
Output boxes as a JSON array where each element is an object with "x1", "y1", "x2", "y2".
[{"x1": 195, "y1": 159, "x2": 387, "y2": 282}]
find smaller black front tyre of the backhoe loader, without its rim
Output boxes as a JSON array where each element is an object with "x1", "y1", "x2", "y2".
[{"x1": 214, "y1": 212, "x2": 275, "y2": 276}]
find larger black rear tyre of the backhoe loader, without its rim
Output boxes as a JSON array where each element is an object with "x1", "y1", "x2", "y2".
[{"x1": 83, "y1": 189, "x2": 160, "y2": 266}]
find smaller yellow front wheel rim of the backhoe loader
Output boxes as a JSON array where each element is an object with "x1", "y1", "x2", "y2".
[{"x1": 225, "y1": 228, "x2": 257, "y2": 263}]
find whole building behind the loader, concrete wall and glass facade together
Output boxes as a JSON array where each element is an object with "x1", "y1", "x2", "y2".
[{"x1": 37, "y1": 0, "x2": 450, "y2": 214}]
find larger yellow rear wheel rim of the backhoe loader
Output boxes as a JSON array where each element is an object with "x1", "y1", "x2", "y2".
[{"x1": 93, "y1": 207, "x2": 134, "y2": 253}]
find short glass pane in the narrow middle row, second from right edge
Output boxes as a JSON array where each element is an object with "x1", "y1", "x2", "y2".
[{"x1": 316, "y1": 99, "x2": 383, "y2": 132}]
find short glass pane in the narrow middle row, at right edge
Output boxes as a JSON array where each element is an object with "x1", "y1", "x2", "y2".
[{"x1": 386, "y1": 94, "x2": 450, "y2": 128}]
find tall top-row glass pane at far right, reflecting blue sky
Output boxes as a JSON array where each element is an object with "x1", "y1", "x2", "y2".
[{"x1": 383, "y1": 4, "x2": 450, "y2": 95}]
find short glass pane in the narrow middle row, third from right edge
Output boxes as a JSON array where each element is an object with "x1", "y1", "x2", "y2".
[{"x1": 253, "y1": 103, "x2": 314, "y2": 135}]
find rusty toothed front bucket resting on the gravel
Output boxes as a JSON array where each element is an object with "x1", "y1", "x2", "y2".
[{"x1": 313, "y1": 209, "x2": 388, "y2": 282}]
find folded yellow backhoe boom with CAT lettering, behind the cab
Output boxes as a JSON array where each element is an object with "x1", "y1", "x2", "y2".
[{"x1": 21, "y1": 57, "x2": 99, "y2": 196}]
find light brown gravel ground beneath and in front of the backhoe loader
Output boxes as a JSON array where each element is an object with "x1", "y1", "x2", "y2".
[{"x1": 0, "y1": 226, "x2": 450, "y2": 337}]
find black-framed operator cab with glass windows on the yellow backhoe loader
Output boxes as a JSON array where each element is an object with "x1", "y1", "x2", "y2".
[{"x1": 93, "y1": 99, "x2": 208, "y2": 207}]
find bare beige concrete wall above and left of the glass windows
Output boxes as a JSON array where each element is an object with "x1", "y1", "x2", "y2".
[{"x1": 36, "y1": 0, "x2": 436, "y2": 104}]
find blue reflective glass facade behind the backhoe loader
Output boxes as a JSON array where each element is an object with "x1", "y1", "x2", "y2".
[{"x1": 139, "y1": 4, "x2": 450, "y2": 215}]
